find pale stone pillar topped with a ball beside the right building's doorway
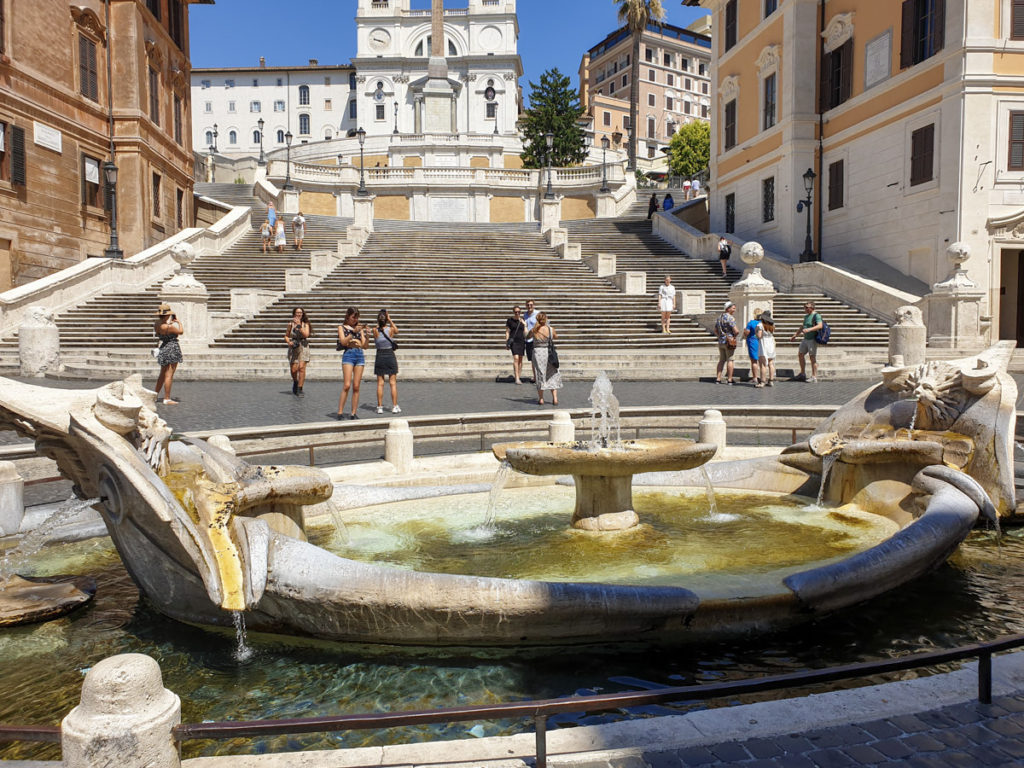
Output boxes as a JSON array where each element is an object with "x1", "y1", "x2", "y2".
[{"x1": 924, "y1": 243, "x2": 987, "y2": 349}]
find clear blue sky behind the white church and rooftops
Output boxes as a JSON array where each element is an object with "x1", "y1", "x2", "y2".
[{"x1": 188, "y1": 0, "x2": 706, "y2": 105}]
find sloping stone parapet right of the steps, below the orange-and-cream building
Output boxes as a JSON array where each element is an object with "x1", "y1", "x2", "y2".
[{"x1": 653, "y1": 201, "x2": 921, "y2": 323}]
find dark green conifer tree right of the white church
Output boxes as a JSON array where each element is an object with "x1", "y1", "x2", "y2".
[{"x1": 519, "y1": 68, "x2": 587, "y2": 168}]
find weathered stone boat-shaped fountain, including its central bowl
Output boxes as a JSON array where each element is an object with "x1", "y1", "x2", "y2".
[{"x1": 0, "y1": 350, "x2": 1016, "y2": 646}]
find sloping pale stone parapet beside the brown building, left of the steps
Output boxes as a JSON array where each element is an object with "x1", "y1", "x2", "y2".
[{"x1": 0, "y1": 207, "x2": 251, "y2": 336}]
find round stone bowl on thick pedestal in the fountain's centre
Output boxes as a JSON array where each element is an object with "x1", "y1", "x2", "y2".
[{"x1": 492, "y1": 438, "x2": 718, "y2": 530}]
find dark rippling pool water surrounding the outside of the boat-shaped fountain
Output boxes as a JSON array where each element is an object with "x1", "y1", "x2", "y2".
[{"x1": 0, "y1": 529, "x2": 1024, "y2": 759}]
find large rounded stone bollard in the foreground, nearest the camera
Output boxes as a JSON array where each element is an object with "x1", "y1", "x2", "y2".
[{"x1": 60, "y1": 653, "x2": 181, "y2": 768}]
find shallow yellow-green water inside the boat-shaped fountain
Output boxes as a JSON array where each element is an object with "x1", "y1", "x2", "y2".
[{"x1": 321, "y1": 485, "x2": 897, "y2": 585}]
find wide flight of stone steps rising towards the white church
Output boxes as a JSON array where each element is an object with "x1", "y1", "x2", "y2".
[{"x1": 0, "y1": 184, "x2": 887, "y2": 379}]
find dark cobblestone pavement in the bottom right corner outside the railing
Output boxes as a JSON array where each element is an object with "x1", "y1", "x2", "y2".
[{"x1": 598, "y1": 694, "x2": 1024, "y2": 768}]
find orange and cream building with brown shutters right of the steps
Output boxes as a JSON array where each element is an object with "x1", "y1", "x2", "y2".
[{"x1": 687, "y1": 0, "x2": 1024, "y2": 339}]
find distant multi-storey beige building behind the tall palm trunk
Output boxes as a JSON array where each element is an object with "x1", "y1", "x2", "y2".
[{"x1": 580, "y1": 19, "x2": 712, "y2": 168}]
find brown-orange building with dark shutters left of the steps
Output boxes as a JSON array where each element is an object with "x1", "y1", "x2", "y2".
[{"x1": 0, "y1": 0, "x2": 205, "y2": 290}]
